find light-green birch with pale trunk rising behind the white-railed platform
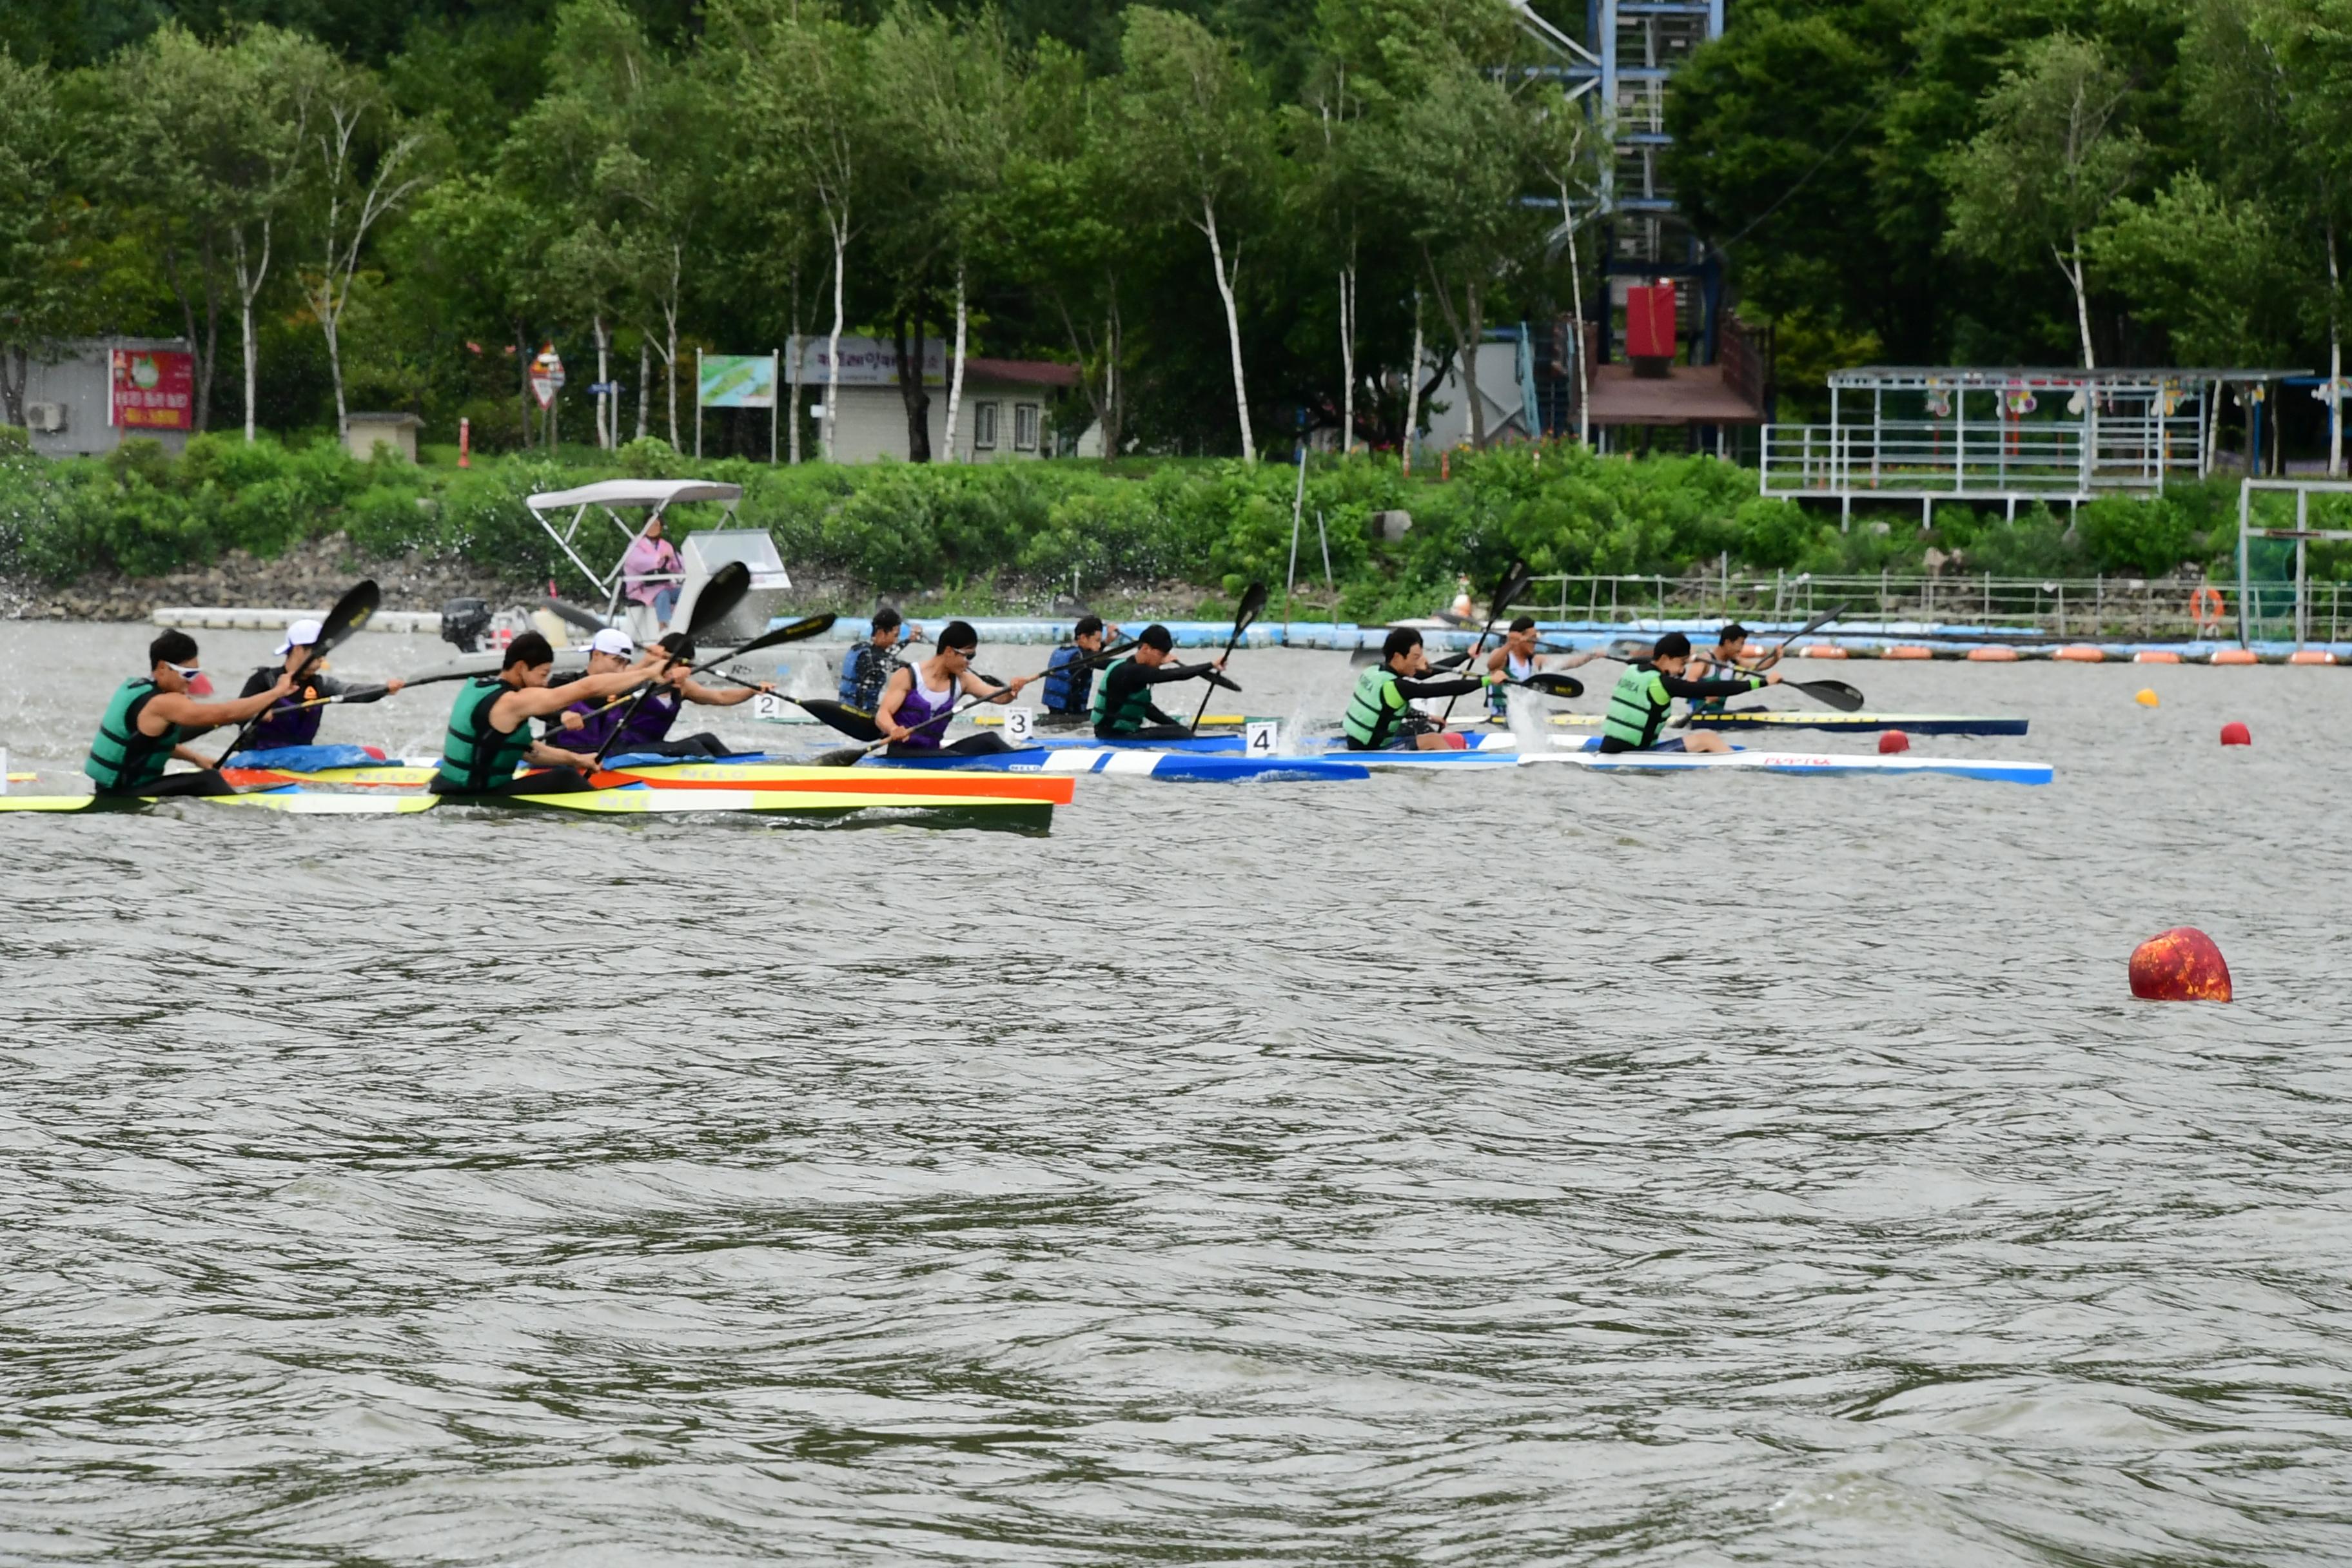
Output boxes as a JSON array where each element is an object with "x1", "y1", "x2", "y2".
[{"x1": 1943, "y1": 33, "x2": 2142, "y2": 369}]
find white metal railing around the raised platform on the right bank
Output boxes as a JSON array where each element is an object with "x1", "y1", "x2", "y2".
[{"x1": 1759, "y1": 414, "x2": 2199, "y2": 501}]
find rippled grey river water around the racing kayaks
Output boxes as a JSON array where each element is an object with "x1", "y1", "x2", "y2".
[{"x1": 0, "y1": 625, "x2": 2352, "y2": 1565}]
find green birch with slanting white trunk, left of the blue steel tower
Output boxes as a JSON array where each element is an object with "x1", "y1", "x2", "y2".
[{"x1": 1119, "y1": 5, "x2": 1275, "y2": 463}]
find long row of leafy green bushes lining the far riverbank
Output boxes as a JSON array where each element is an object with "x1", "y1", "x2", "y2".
[{"x1": 0, "y1": 433, "x2": 2314, "y2": 618}]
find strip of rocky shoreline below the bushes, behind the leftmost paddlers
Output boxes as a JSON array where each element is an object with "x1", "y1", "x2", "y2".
[{"x1": 0, "y1": 534, "x2": 515, "y2": 621}]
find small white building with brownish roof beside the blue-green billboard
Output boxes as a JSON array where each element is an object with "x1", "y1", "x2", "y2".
[{"x1": 799, "y1": 336, "x2": 1077, "y2": 463}]
